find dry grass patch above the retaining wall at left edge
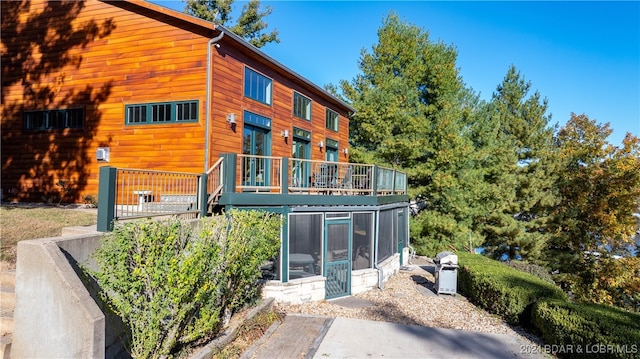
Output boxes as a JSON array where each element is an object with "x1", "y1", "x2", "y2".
[{"x1": 0, "y1": 205, "x2": 97, "y2": 269}]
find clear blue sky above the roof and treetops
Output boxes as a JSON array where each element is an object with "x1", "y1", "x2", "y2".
[{"x1": 154, "y1": 0, "x2": 640, "y2": 145}]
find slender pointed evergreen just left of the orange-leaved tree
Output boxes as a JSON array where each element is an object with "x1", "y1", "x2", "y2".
[{"x1": 483, "y1": 66, "x2": 557, "y2": 262}]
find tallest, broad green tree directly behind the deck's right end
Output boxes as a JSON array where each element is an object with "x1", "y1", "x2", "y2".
[{"x1": 341, "y1": 13, "x2": 516, "y2": 254}]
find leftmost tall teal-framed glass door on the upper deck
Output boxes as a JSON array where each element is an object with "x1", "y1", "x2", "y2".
[{"x1": 242, "y1": 125, "x2": 270, "y2": 186}]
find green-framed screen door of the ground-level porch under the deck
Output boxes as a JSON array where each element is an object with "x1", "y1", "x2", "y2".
[{"x1": 324, "y1": 219, "x2": 351, "y2": 299}]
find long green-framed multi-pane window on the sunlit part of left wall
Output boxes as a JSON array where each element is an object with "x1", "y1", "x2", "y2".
[{"x1": 125, "y1": 101, "x2": 199, "y2": 125}]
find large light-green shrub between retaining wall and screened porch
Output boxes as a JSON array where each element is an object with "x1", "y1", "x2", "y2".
[{"x1": 92, "y1": 211, "x2": 280, "y2": 358}]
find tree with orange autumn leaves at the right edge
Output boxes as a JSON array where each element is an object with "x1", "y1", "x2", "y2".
[{"x1": 548, "y1": 114, "x2": 640, "y2": 279}]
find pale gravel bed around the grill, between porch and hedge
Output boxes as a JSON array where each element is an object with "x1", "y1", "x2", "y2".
[{"x1": 282, "y1": 257, "x2": 543, "y2": 345}]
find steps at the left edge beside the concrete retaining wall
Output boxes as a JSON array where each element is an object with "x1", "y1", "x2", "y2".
[{"x1": 0, "y1": 270, "x2": 16, "y2": 359}]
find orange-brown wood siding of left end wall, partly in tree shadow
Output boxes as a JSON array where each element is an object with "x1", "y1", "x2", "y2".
[{"x1": 2, "y1": 1, "x2": 213, "y2": 201}]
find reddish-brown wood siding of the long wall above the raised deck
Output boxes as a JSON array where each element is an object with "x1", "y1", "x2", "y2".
[{"x1": 212, "y1": 38, "x2": 349, "y2": 162}]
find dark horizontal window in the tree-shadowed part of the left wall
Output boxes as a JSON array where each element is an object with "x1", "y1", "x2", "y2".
[{"x1": 24, "y1": 108, "x2": 84, "y2": 131}]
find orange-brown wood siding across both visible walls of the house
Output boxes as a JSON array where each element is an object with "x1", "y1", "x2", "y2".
[{"x1": 0, "y1": 0, "x2": 348, "y2": 202}]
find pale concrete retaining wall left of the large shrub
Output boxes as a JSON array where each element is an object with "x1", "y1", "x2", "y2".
[{"x1": 11, "y1": 233, "x2": 127, "y2": 358}]
